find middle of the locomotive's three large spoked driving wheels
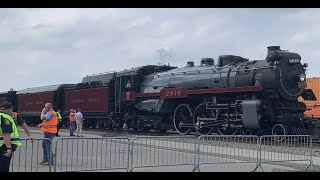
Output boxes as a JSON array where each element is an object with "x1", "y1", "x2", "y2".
[{"x1": 193, "y1": 103, "x2": 216, "y2": 135}]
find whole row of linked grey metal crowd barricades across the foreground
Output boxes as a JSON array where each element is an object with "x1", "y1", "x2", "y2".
[{"x1": 10, "y1": 135, "x2": 318, "y2": 172}]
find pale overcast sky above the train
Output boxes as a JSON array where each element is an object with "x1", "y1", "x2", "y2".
[{"x1": 0, "y1": 8, "x2": 320, "y2": 91}]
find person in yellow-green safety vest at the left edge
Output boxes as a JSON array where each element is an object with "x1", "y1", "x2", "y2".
[{"x1": 0, "y1": 101, "x2": 21, "y2": 172}]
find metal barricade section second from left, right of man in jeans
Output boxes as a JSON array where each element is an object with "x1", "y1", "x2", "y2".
[{"x1": 54, "y1": 137, "x2": 130, "y2": 172}]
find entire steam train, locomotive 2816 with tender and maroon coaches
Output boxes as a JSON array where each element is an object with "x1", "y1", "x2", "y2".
[{"x1": 0, "y1": 46, "x2": 316, "y2": 135}]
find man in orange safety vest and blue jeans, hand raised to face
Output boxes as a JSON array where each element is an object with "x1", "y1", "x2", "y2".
[{"x1": 38, "y1": 103, "x2": 58, "y2": 165}]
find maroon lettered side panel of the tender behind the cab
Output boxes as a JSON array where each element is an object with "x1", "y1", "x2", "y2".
[{"x1": 65, "y1": 87, "x2": 109, "y2": 112}]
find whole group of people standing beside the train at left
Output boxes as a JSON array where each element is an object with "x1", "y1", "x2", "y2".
[{"x1": 0, "y1": 101, "x2": 84, "y2": 172}]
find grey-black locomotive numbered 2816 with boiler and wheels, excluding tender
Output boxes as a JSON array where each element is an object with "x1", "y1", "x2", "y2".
[{"x1": 122, "y1": 46, "x2": 315, "y2": 135}]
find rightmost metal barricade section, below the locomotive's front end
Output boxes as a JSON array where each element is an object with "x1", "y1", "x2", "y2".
[{"x1": 259, "y1": 135, "x2": 318, "y2": 171}]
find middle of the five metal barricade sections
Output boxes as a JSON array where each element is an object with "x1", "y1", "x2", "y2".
[{"x1": 131, "y1": 136, "x2": 196, "y2": 171}]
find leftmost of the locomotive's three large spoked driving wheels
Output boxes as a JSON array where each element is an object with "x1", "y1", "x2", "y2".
[{"x1": 173, "y1": 104, "x2": 193, "y2": 135}]
